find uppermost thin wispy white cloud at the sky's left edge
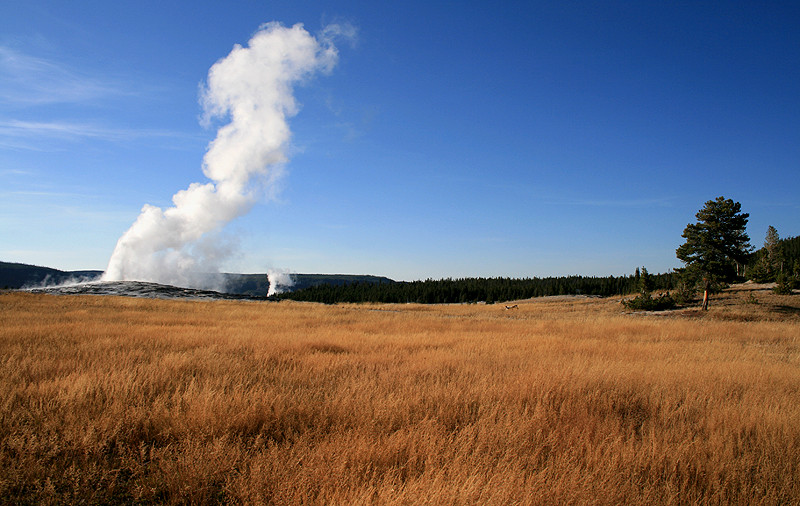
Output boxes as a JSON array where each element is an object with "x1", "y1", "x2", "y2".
[{"x1": 0, "y1": 46, "x2": 130, "y2": 106}]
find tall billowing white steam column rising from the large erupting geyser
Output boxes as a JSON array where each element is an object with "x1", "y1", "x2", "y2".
[{"x1": 103, "y1": 23, "x2": 342, "y2": 288}]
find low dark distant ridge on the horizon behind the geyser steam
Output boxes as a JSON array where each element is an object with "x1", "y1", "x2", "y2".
[{"x1": 0, "y1": 262, "x2": 395, "y2": 297}]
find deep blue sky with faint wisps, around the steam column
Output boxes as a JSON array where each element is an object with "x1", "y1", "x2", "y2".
[{"x1": 0, "y1": 0, "x2": 800, "y2": 280}]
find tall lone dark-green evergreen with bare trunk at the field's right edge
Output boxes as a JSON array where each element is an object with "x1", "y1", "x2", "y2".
[{"x1": 675, "y1": 197, "x2": 752, "y2": 310}]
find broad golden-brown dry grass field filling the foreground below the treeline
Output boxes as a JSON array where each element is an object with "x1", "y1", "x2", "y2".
[{"x1": 0, "y1": 291, "x2": 800, "y2": 505}]
